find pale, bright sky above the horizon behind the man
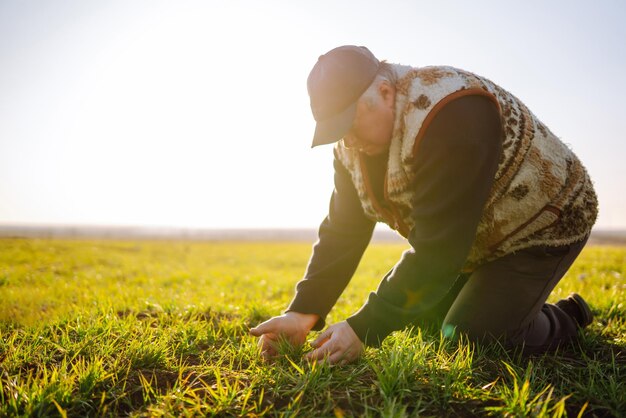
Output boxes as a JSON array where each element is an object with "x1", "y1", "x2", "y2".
[{"x1": 0, "y1": 0, "x2": 626, "y2": 229}]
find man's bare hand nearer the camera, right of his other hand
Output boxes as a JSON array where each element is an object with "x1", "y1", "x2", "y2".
[{"x1": 306, "y1": 321, "x2": 363, "y2": 364}]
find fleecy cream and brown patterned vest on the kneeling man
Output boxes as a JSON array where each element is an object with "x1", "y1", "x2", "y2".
[{"x1": 335, "y1": 65, "x2": 597, "y2": 271}]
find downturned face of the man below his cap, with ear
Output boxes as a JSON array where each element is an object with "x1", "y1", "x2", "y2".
[{"x1": 343, "y1": 81, "x2": 395, "y2": 156}]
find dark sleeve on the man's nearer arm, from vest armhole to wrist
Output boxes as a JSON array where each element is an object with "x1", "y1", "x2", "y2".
[{"x1": 348, "y1": 96, "x2": 502, "y2": 346}]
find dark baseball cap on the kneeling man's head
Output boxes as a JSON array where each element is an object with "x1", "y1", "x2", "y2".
[{"x1": 307, "y1": 45, "x2": 380, "y2": 147}]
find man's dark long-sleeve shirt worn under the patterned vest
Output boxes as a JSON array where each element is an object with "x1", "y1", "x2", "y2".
[{"x1": 287, "y1": 96, "x2": 502, "y2": 345}]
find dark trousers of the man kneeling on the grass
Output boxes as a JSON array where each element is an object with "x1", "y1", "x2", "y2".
[{"x1": 418, "y1": 239, "x2": 587, "y2": 353}]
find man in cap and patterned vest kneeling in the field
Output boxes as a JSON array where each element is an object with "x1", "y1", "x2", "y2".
[{"x1": 250, "y1": 46, "x2": 597, "y2": 364}]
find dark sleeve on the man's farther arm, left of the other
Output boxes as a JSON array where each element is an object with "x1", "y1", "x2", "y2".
[{"x1": 286, "y1": 153, "x2": 375, "y2": 330}]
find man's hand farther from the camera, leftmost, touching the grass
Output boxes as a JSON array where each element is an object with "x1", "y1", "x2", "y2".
[{"x1": 250, "y1": 311, "x2": 319, "y2": 359}]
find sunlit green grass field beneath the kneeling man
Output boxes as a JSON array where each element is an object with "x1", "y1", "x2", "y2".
[{"x1": 0, "y1": 239, "x2": 626, "y2": 417}]
